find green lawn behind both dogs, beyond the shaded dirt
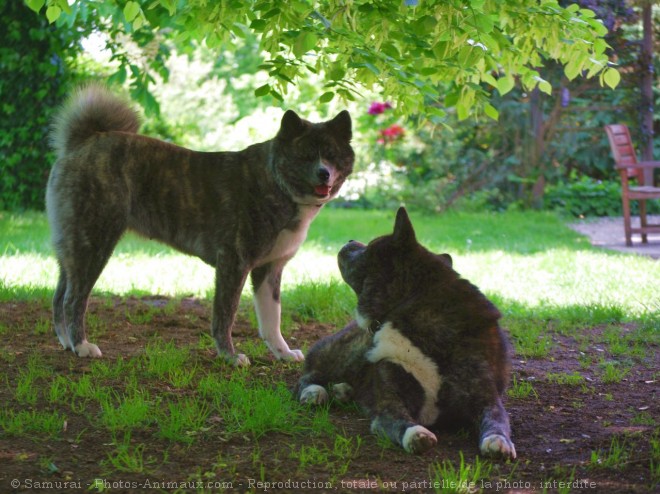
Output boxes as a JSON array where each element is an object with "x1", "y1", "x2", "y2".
[{"x1": 0, "y1": 209, "x2": 660, "y2": 318}]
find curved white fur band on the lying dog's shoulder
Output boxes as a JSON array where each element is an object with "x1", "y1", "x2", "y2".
[{"x1": 366, "y1": 322, "x2": 442, "y2": 425}]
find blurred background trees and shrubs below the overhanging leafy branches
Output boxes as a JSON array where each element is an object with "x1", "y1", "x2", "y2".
[{"x1": 0, "y1": 0, "x2": 660, "y2": 217}]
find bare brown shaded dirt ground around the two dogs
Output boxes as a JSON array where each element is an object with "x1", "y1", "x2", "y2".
[{"x1": 0, "y1": 297, "x2": 660, "y2": 492}]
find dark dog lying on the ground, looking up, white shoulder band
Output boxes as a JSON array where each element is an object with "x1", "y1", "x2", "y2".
[{"x1": 297, "y1": 208, "x2": 516, "y2": 458}]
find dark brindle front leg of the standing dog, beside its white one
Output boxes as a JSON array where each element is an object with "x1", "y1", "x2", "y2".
[{"x1": 211, "y1": 249, "x2": 250, "y2": 366}]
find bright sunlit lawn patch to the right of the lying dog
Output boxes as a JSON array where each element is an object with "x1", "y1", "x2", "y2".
[{"x1": 454, "y1": 249, "x2": 660, "y2": 314}]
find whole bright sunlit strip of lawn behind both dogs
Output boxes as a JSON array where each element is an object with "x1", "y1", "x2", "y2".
[{"x1": 0, "y1": 245, "x2": 660, "y2": 315}]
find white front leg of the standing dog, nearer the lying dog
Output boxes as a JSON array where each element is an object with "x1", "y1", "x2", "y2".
[{"x1": 251, "y1": 262, "x2": 305, "y2": 362}]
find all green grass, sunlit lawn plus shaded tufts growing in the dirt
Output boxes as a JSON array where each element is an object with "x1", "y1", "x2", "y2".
[{"x1": 0, "y1": 209, "x2": 660, "y2": 491}]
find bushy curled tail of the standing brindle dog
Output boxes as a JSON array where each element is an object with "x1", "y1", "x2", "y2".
[{"x1": 50, "y1": 84, "x2": 140, "y2": 158}]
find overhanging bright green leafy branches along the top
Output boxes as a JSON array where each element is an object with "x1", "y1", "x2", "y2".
[{"x1": 26, "y1": 0, "x2": 619, "y2": 118}]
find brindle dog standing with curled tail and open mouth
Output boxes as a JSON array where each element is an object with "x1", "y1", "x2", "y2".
[{"x1": 46, "y1": 86, "x2": 354, "y2": 365}]
